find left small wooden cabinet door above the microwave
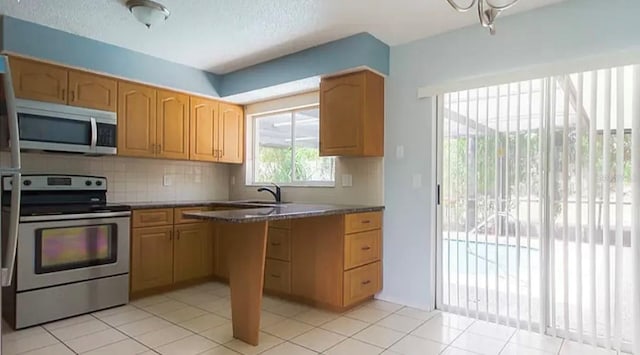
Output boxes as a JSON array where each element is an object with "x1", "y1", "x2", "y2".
[{"x1": 9, "y1": 57, "x2": 69, "y2": 105}]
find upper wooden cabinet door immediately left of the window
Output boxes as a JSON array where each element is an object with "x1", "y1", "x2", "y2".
[{"x1": 218, "y1": 103, "x2": 244, "y2": 164}]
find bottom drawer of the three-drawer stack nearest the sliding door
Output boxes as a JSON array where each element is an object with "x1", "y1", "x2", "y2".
[{"x1": 343, "y1": 261, "x2": 382, "y2": 307}]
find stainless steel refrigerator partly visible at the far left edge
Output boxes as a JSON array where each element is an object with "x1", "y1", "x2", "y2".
[{"x1": 0, "y1": 55, "x2": 21, "y2": 354}]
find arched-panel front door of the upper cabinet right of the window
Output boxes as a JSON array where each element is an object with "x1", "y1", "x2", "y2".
[{"x1": 320, "y1": 73, "x2": 365, "y2": 156}]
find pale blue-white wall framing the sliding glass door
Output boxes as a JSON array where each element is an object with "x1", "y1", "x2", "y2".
[{"x1": 379, "y1": 0, "x2": 640, "y2": 308}]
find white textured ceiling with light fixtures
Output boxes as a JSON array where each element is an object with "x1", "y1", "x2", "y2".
[{"x1": 0, "y1": 0, "x2": 561, "y2": 73}]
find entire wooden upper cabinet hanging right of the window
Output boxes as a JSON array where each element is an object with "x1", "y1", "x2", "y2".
[{"x1": 320, "y1": 70, "x2": 384, "y2": 156}]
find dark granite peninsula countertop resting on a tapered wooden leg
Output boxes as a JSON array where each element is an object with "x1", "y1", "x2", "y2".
[{"x1": 184, "y1": 203, "x2": 384, "y2": 223}]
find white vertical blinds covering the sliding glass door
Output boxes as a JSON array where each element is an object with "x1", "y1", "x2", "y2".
[{"x1": 437, "y1": 66, "x2": 640, "y2": 351}]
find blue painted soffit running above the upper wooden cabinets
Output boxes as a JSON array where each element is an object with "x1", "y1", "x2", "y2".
[{"x1": 0, "y1": 15, "x2": 389, "y2": 97}]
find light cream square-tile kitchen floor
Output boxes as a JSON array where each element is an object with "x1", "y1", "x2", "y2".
[{"x1": 2, "y1": 282, "x2": 632, "y2": 355}]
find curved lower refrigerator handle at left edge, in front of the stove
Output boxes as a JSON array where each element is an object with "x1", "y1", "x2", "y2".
[{"x1": 2, "y1": 173, "x2": 22, "y2": 287}]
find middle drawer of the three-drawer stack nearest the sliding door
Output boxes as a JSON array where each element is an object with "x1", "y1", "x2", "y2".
[{"x1": 344, "y1": 229, "x2": 382, "y2": 270}]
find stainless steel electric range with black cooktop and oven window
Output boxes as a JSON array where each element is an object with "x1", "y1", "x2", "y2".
[{"x1": 2, "y1": 175, "x2": 131, "y2": 329}]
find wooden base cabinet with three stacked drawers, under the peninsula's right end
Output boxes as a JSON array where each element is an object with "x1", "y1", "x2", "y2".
[{"x1": 291, "y1": 212, "x2": 382, "y2": 309}]
